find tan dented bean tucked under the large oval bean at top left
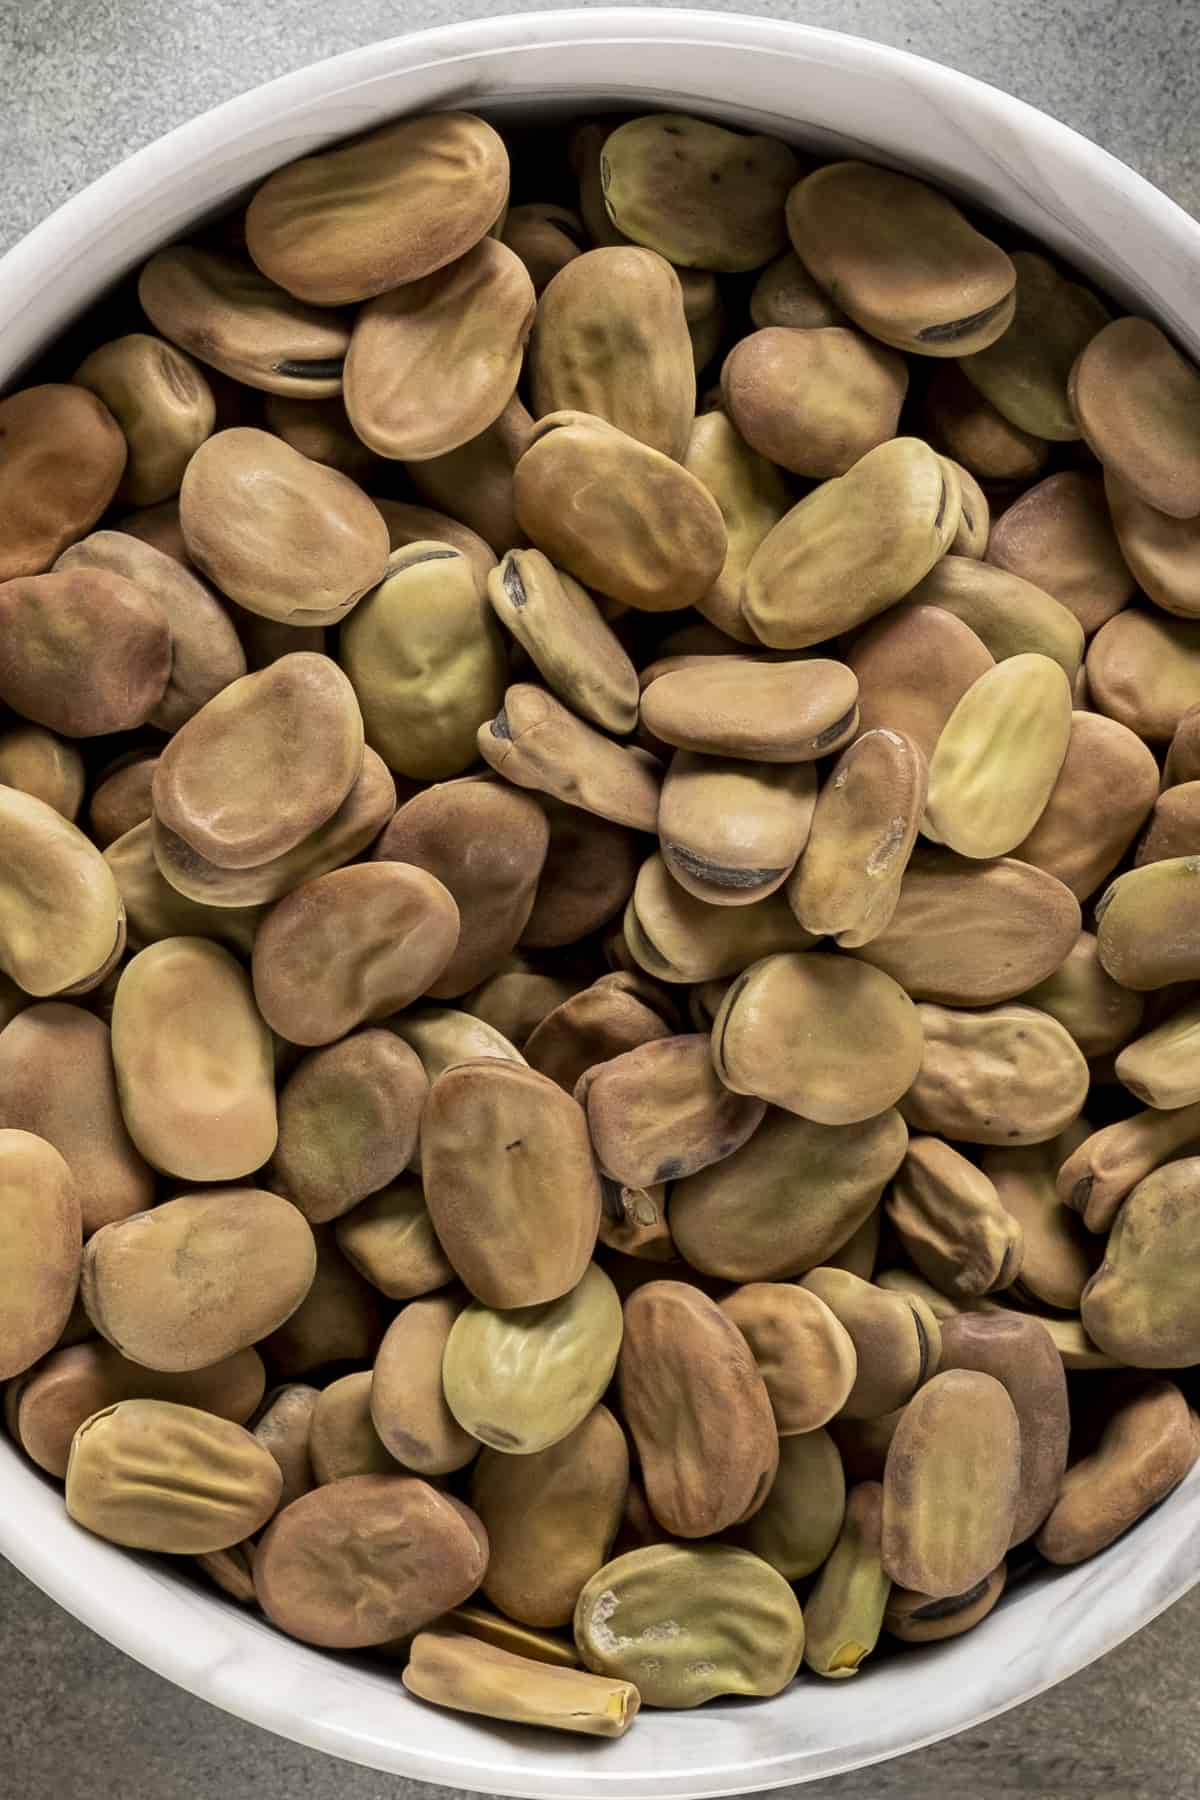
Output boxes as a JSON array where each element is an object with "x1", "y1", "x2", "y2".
[{"x1": 345, "y1": 238, "x2": 536, "y2": 463}]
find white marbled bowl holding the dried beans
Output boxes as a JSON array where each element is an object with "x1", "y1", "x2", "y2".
[{"x1": 0, "y1": 9, "x2": 1200, "y2": 1800}]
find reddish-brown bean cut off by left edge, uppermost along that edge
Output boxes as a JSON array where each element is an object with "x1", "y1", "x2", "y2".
[{"x1": 0, "y1": 382, "x2": 128, "y2": 581}]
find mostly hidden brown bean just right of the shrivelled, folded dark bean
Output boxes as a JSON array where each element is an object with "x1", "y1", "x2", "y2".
[{"x1": 981, "y1": 1144, "x2": 1101, "y2": 1312}]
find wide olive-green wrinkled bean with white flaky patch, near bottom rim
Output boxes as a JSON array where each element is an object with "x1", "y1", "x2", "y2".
[{"x1": 576, "y1": 1544, "x2": 804, "y2": 1708}]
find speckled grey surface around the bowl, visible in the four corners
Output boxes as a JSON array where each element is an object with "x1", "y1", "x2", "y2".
[{"x1": 0, "y1": 0, "x2": 1200, "y2": 1800}]
